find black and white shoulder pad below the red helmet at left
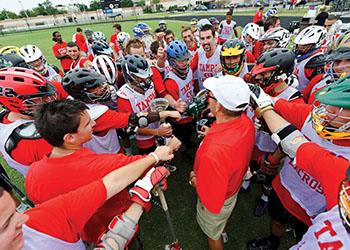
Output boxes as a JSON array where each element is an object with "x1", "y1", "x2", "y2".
[{"x1": 5, "y1": 121, "x2": 41, "y2": 154}]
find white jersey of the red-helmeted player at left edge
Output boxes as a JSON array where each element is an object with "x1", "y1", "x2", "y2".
[{"x1": 0, "y1": 119, "x2": 33, "y2": 176}]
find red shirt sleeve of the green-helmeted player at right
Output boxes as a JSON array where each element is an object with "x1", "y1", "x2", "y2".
[{"x1": 296, "y1": 142, "x2": 349, "y2": 210}]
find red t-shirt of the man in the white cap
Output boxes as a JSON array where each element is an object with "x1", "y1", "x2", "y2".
[{"x1": 194, "y1": 114, "x2": 255, "y2": 214}]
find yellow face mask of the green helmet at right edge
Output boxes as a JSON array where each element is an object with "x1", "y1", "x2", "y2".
[{"x1": 311, "y1": 102, "x2": 350, "y2": 140}]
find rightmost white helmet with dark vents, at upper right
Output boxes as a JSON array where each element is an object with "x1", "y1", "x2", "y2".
[{"x1": 294, "y1": 25, "x2": 327, "y2": 47}]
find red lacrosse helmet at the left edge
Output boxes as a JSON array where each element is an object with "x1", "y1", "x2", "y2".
[{"x1": 0, "y1": 68, "x2": 57, "y2": 115}]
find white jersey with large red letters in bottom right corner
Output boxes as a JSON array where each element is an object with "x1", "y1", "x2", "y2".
[{"x1": 290, "y1": 205, "x2": 350, "y2": 250}]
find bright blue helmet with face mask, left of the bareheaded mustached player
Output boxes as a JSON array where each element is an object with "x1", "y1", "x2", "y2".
[{"x1": 166, "y1": 40, "x2": 191, "y2": 76}]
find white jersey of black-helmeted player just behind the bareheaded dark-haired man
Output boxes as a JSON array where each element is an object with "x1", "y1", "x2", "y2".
[{"x1": 84, "y1": 104, "x2": 120, "y2": 154}]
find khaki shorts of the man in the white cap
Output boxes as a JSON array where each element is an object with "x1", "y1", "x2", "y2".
[{"x1": 197, "y1": 192, "x2": 238, "y2": 240}]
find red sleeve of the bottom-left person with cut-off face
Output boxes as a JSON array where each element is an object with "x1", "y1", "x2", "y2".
[{"x1": 25, "y1": 179, "x2": 106, "y2": 243}]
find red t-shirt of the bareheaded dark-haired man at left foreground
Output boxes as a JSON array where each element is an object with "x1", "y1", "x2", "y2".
[{"x1": 25, "y1": 148, "x2": 143, "y2": 242}]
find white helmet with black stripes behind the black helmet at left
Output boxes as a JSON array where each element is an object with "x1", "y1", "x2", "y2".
[{"x1": 92, "y1": 55, "x2": 118, "y2": 85}]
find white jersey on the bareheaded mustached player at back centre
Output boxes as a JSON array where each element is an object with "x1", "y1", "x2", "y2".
[{"x1": 196, "y1": 45, "x2": 221, "y2": 90}]
